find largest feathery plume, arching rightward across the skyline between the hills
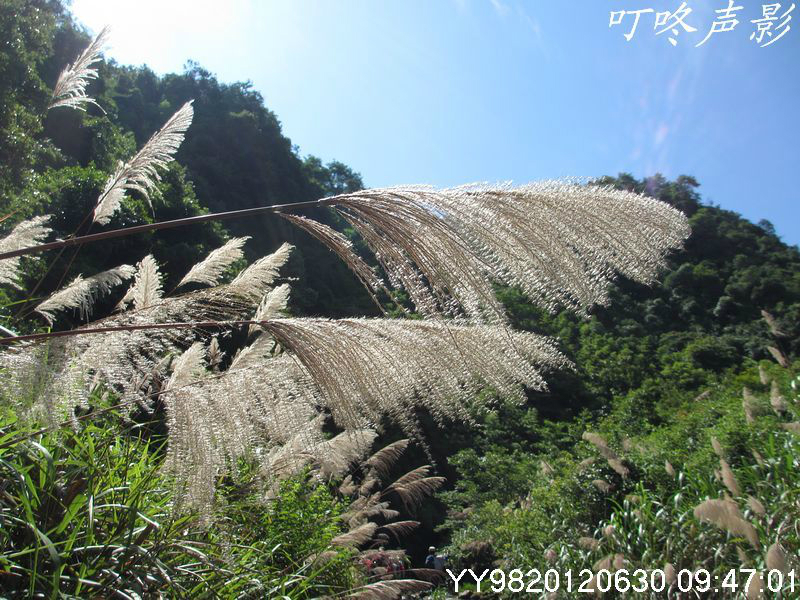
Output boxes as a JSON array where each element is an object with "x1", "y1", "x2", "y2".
[{"x1": 286, "y1": 181, "x2": 689, "y2": 322}]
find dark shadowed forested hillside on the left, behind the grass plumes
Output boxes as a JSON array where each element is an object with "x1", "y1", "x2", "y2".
[{"x1": 0, "y1": 2, "x2": 375, "y2": 324}]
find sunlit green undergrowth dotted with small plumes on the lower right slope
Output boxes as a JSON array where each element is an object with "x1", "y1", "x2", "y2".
[{"x1": 449, "y1": 363, "x2": 800, "y2": 598}]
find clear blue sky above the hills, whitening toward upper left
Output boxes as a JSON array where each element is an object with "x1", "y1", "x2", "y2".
[{"x1": 72, "y1": 0, "x2": 800, "y2": 244}]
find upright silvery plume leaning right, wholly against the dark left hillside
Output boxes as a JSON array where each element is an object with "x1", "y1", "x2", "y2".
[{"x1": 93, "y1": 101, "x2": 194, "y2": 225}]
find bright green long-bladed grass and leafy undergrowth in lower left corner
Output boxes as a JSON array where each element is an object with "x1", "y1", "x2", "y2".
[{"x1": 0, "y1": 404, "x2": 365, "y2": 598}]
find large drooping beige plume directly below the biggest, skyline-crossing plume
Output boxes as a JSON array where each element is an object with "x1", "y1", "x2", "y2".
[{"x1": 264, "y1": 319, "x2": 570, "y2": 432}]
